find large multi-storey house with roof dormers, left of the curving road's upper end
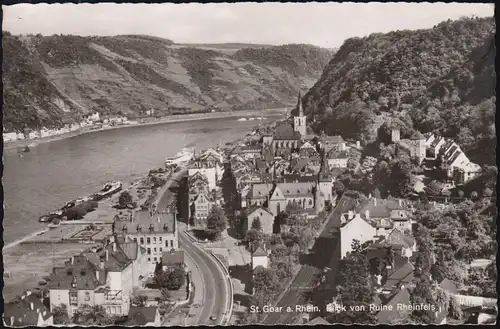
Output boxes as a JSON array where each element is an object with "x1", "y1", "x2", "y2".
[{"x1": 114, "y1": 208, "x2": 179, "y2": 271}]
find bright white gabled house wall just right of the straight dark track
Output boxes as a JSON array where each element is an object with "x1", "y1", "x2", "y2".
[{"x1": 340, "y1": 211, "x2": 376, "y2": 258}]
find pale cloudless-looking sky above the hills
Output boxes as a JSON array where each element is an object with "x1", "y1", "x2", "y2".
[{"x1": 3, "y1": 2, "x2": 494, "y2": 48}]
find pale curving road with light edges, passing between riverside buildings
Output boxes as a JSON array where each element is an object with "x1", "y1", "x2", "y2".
[{"x1": 156, "y1": 170, "x2": 229, "y2": 325}]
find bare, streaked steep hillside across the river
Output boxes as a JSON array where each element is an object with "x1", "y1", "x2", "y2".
[{"x1": 3, "y1": 32, "x2": 333, "y2": 131}]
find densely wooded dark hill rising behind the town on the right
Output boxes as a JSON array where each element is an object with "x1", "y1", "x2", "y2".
[{"x1": 303, "y1": 18, "x2": 496, "y2": 165}]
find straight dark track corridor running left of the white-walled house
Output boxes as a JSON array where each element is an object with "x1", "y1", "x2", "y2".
[{"x1": 262, "y1": 197, "x2": 355, "y2": 325}]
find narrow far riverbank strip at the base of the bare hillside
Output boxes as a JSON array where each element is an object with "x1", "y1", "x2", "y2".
[{"x1": 4, "y1": 108, "x2": 286, "y2": 151}]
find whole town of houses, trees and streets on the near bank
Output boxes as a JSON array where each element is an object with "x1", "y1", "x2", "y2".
[{"x1": 4, "y1": 93, "x2": 497, "y2": 326}]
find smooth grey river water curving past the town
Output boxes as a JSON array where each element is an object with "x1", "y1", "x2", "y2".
[{"x1": 3, "y1": 116, "x2": 278, "y2": 245}]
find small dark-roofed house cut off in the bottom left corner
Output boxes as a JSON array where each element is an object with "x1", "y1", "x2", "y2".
[{"x1": 3, "y1": 291, "x2": 54, "y2": 327}]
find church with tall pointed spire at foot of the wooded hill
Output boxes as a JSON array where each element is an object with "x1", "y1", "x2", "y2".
[{"x1": 262, "y1": 91, "x2": 307, "y2": 155}]
